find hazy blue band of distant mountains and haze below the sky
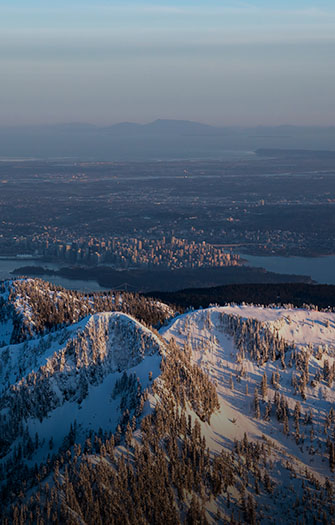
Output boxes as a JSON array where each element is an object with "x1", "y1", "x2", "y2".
[{"x1": 0, "y1": 119, "x2": 335, "y2": 161}]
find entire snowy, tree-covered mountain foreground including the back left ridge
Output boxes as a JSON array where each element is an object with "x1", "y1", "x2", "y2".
[{"x1": 0, "y1": 280, "x2": 335, "y2": 524}]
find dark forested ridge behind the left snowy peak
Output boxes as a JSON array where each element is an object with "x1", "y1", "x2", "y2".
[{"x1": 0, "y1": 279, "x2": 175, "y2": 347}]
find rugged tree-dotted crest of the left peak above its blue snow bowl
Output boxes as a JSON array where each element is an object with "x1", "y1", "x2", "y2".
[{"x1": 0, "y1": 312, "x2": 164, "y2": 462}]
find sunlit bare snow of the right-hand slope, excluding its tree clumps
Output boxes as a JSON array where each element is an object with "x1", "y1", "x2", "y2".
[{"x1": 161, "y1": 306, "x2": 335, "y2": 494}]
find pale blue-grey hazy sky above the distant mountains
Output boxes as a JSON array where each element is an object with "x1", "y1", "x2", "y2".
[{"x1": 0, "y1": 0, "x2": 335, "y2": 125}]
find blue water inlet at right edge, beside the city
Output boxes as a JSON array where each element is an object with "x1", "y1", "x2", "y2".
[{"x1": 240, "y1": 254, "x2": 335, "y2": 284}]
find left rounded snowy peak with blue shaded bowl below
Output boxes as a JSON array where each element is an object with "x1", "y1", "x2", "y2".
[{"x1": 0, "y1": 312, "x2": 164, "y2": 470}]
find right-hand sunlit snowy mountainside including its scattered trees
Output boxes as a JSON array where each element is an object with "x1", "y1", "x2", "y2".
[{"x1": 161, "y1": 305, "x2": 335, "y2": 523}]
